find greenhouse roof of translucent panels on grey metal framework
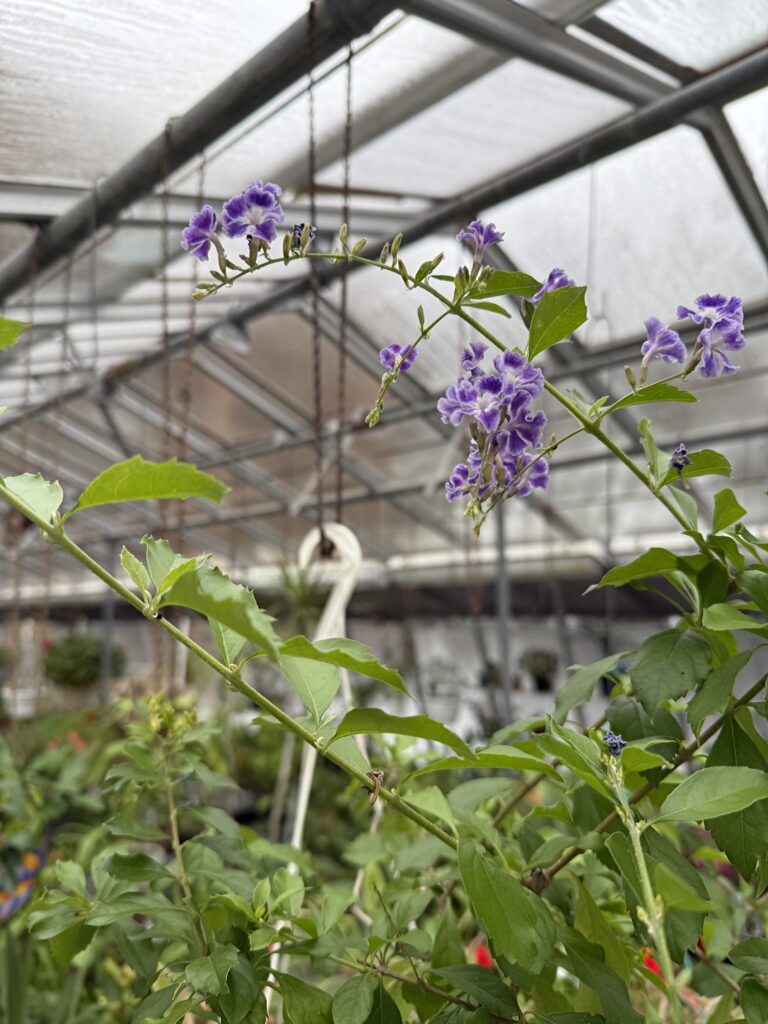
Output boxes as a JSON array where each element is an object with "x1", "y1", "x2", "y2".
[{"x1": 0, "y1": 0, "x2": 768, "y2": 597}]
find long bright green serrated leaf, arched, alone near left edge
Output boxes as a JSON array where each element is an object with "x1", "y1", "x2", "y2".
[{"x1": 62, "y1": 455, "x2": 229, "y2": 520}]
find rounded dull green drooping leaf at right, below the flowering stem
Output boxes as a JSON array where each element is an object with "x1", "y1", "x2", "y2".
[{"x1": 630, "y1": 630, "x2": 712, "y2": 715}]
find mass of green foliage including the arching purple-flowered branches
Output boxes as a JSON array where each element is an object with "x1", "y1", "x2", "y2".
[{"x1": 0, "y1": 211, "x2": 768, "y2": 1024}]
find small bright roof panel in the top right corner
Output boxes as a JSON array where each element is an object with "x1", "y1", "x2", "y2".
[{"x1": 599, "y1": 0, "x2": 768, "y2": 71}]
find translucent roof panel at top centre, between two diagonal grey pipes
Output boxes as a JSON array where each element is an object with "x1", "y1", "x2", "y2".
[{"x1": 319, "y1": 60, "x2": 630, "y2": 198}]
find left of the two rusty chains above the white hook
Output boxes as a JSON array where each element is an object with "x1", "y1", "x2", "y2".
[{"x1": 307, "y1": 0, "x2": 328, "y2": 553}]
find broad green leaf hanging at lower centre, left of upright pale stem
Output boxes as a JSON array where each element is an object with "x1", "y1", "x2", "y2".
[{"x1": 459, "y1": 840, "x2": 555, "y2": 974}]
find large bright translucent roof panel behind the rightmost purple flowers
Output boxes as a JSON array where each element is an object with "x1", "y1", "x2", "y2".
[{"x1": 485, "y1": 127, "x2": 766, "y2": 343}]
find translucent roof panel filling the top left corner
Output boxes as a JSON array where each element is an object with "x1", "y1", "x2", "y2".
[{"x1": 0, "y1": 0, "x2": 306, "y2": 181}]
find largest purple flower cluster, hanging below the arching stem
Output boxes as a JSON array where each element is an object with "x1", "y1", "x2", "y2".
[{"x1": 437, "y1": 341, "x2": 549, "y2": 515}]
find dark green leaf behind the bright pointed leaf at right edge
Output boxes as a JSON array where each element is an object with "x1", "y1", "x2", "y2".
[{"x1": 706, "y1": 715, "x2": 768, "y2": 882}]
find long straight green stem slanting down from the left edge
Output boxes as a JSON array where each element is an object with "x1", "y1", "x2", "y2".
[{"x1": 0, "y1": 481, "x2": 459, "y2": 850}]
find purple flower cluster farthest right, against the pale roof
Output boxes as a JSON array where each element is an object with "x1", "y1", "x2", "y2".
[{"x1": 640, "y1": 295, "x2": 746, "y2": 384}]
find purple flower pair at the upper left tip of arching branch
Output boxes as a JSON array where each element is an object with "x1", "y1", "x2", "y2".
[{"x1": 181, "y1": 181, "x2": 286, "y2": 260}]
